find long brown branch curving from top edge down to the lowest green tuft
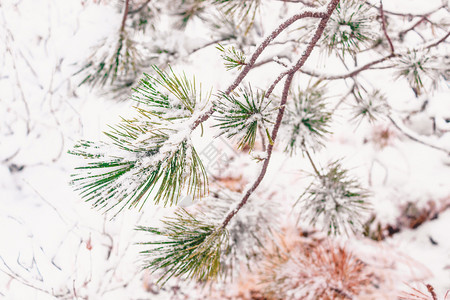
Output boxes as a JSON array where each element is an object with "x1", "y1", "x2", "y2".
[{"x1": 221, "y1": 0, "x2": 340, "y2": 228}]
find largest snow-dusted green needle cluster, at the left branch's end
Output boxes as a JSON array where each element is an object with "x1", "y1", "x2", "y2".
[{"x1": 70, "y1": 67, "x2": 208, "y2": 213}]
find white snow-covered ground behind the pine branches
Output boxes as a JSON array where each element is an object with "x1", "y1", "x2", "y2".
[{"x1": 0, "y1": 0, "x2": 450, "y2": 299}]
